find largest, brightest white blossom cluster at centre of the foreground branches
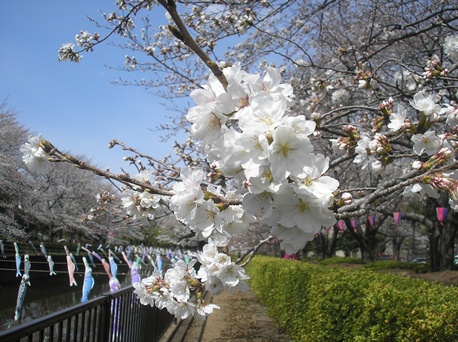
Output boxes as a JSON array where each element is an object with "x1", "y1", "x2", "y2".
[{"x1": 182, "y1": 64, "x2": 339, "y2": 253}]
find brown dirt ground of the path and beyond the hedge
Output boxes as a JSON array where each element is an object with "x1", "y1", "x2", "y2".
[{"x1": 184, "y1": 265, "x2": 458, "y2": 342}]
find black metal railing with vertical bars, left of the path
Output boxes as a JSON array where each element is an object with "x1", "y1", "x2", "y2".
[{"x1": 0, "y1": 286, "x2": 173, "y2": 342}]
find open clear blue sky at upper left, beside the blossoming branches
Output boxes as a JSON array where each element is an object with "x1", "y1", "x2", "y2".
[{"x1": 0, "y1": 0, "x2": 186, "y2": 172}]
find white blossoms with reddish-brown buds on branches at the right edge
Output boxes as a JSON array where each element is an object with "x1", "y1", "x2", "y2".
[{"x1": 331, "y1": 87, "x2": 458, "y2": 210}]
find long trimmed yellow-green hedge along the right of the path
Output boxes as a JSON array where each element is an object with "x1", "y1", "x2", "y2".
[{"x1": 246, "y1": 257, "x2": 458, "y2": 342}]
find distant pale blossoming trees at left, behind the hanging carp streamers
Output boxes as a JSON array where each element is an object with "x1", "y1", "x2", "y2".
[{"x1": 0, "y1": 101, "x2": 131, "y2": 242}]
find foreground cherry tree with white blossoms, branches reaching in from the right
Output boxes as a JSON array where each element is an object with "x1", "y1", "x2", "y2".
[{"x1": 22, "y1": 0, "x2": 458, "y2": 318}]
